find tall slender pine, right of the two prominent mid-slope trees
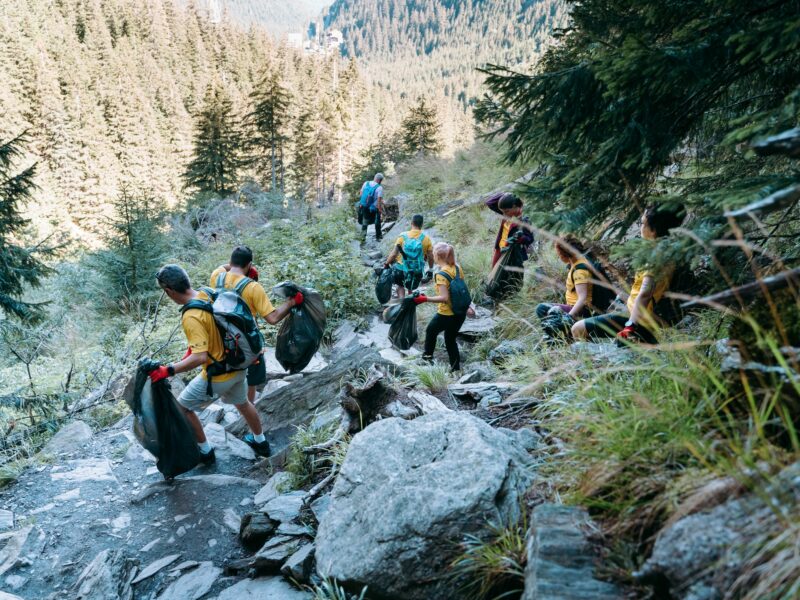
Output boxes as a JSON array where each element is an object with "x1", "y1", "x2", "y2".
[{"x1": 247, "y1": 69, "x2": 289, "y2": 192}]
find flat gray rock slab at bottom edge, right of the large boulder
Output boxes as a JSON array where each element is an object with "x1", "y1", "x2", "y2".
[{"x1": 522, "y1": 504, "x2": 625, "y2": 600}]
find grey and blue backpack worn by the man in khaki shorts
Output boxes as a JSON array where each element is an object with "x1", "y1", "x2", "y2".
[{"x1": 181, "y1": 273, "x2": 264, "y2": 396}]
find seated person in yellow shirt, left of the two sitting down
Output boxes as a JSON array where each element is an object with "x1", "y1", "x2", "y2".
[{"x1": 536, "y1": 235, "x2": 594, "y2": 338}]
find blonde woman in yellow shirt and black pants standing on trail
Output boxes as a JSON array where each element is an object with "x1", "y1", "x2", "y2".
[{"x1": 412, "y1": 242, "x2": 472, "y2": 371}]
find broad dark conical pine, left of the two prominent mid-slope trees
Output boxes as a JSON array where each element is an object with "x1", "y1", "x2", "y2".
[{"x1": 183, "y1": 86, "x2": 244, "y2": 194}]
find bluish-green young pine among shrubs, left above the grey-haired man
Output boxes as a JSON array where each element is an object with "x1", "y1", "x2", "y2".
[{"x1": 93, "y1": 187, "x2": 165, "y2": 310}]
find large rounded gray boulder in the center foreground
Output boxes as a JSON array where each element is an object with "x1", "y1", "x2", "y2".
[{"x1": 316, "y1": 412, "x2": 533, "y2": 600}]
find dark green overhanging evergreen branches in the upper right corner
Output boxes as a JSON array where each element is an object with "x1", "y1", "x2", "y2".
[{"x1": 477, "y1": 0, "x2": 800, "y2": 248}]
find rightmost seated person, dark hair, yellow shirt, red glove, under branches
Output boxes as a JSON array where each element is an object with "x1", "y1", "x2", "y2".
[{"x1": 572, "y1": 207, "x2": 683, "y2": 344}]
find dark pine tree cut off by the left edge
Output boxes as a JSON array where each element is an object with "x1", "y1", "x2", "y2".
[{"x1": 0, "y1": 133, "x2": 48, "y2": 319}]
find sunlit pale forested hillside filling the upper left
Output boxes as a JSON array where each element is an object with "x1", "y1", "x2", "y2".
[{"x1": 0, "y1": 0, "x2": 377, "y2": 240}]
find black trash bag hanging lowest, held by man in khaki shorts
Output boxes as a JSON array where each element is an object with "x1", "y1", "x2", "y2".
[{"x1": 125, "y1": 359, "x2": 200, "y2": 479}]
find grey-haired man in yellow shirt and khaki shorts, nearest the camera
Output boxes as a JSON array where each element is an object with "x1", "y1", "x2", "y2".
[{"x1": 149, "y1": 265, "x2": 303, "y2": 464}]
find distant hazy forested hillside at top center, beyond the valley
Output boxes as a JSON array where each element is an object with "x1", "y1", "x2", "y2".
[{"x1": 325, "y1": 0, "x2": 568, "y2": 145}]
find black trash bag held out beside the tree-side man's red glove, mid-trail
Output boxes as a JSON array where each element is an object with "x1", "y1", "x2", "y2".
[{"x1": 272, "y1": 281, "x2": 327, "y2": 373}]
